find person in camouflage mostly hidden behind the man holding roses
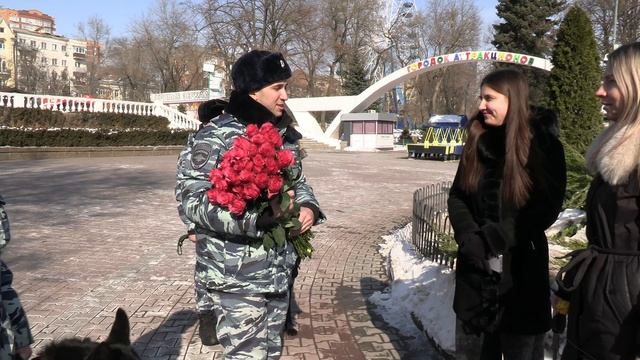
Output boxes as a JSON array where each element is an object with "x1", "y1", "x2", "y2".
[{"x1": 176, "y1": 99, "x2": 228, "y2": 346}]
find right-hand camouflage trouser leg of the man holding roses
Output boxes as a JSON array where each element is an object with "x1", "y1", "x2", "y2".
[{"x1": 266, "y1": 293, "x2": 290, "y2": 359}]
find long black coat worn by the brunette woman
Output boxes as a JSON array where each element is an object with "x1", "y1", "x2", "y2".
[{"x1": 448, "y1": 110, "x2": 566, "y2": 334}]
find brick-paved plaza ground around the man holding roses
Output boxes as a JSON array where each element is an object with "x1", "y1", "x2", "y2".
[{"x1": 0, "y1": 152, "x2": 457, "y2": 360}]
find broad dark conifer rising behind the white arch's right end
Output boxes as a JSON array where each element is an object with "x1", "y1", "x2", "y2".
[{"x1": 491, "y1": 0, "x2": 566, "y2": 103}]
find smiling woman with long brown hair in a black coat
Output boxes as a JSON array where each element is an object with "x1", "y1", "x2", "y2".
[{"x1": 448, "y1": 69, "x2": 566, "y2": 360}]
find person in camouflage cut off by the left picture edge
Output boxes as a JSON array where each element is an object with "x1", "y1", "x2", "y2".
[{"x1": 0, "y1": 195, "x2": 33, "y2": 360}]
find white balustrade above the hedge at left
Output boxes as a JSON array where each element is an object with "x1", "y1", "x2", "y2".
[{"x1": 0, "y1": 92, "x2": 200, "y2": 129}]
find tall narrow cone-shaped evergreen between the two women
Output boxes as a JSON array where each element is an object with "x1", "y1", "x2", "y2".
[{"x1": 549, "y1": 6, "x2": 603, "y2": 154}]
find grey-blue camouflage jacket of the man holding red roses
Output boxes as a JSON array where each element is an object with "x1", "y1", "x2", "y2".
[{"x1": 176, "y1": 114, "x2": 324, "y2": 294}]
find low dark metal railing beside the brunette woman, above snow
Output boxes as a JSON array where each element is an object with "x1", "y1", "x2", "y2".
[{"x1": 411, "y1": 181, "x2": 456, "y2": 269}]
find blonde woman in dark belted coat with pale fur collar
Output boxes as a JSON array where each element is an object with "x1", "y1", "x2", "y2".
[{"x1": 559, "y1": 42, "x2": 640, "y2": 360}]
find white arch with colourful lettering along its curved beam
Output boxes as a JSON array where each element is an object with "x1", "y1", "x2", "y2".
[{"x1": 286, "y1": 50, "x2": 553, "y2": 147}]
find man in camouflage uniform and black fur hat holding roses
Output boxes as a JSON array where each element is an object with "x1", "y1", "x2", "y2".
[{"x1": 177, "y1": 50, "x2": 324, "y2": 359}]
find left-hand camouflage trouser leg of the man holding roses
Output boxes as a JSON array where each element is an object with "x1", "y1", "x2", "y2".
[{"x1": 209, "y1": 290, "x2": 268, "y2": 360}]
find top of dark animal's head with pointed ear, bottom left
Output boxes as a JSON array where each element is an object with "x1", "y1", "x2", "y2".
[{"x1": 33, "y1": 308, "x2": 140, "y2": 360}]
